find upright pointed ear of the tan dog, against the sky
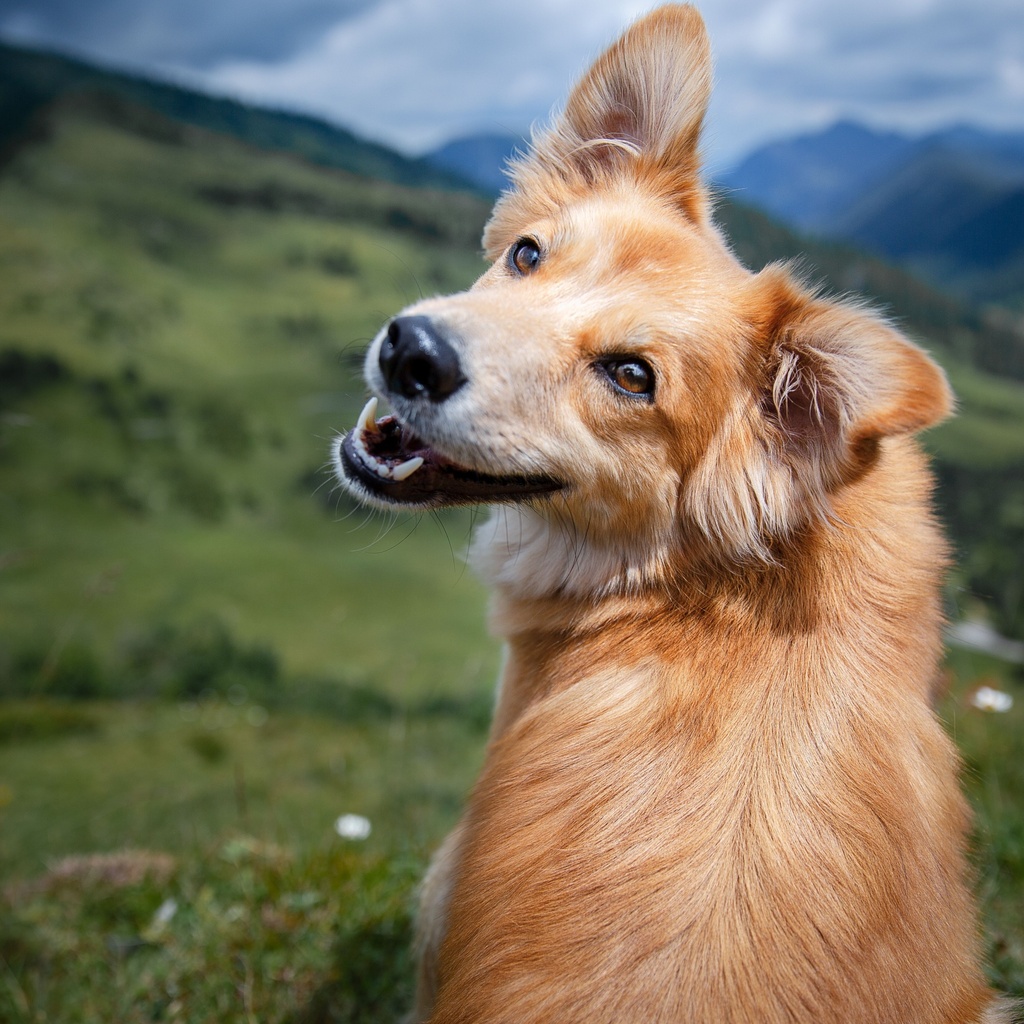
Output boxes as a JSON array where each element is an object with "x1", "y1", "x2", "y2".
[{"x1": 491, "y1": 4, "x2": 712, "y2": 233}]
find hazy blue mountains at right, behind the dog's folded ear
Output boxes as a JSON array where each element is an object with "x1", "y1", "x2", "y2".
[{"x1": 721, "y1": 123, "x2": 1024, "y2": 308}]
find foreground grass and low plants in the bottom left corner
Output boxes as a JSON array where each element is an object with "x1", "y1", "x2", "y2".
[{"x1": 0, "y1": 835, "x2": 419, "y2": 1024}]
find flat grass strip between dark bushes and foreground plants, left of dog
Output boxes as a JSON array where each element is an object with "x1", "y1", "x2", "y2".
[{"x1": 0, "y1": 697, "x2": 484, "y2": 879}]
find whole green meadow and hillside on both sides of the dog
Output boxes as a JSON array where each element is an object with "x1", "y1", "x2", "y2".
[{"x1": 0, "y1": 86, "x2": 1024, "y2": 1022}]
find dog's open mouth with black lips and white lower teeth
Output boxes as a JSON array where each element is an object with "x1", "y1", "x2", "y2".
[{"x1": 338, "y1": 398, "x2": 561, "y2": 508}]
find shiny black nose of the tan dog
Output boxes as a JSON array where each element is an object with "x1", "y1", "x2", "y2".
[{"x1": 378, "y1": 316, "x2": 466, "y2": 401}]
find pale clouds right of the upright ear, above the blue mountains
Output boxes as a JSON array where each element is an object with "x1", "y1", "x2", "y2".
[{"x1": 705, "y1": 0, "x2": 1024, "y2": 162}]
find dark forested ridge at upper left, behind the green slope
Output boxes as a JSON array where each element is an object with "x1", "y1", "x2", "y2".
[{"x1": 0, "y1": 42, "x2": 471, "y2": 188}]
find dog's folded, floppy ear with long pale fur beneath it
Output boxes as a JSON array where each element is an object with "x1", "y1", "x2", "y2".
[{"x1": 684, "y1": 267, "x2": 953, "y2": 559}]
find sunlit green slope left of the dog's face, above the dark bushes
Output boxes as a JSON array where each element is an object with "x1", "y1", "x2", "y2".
[{"x1": 0, "y1": 94, "x2": 495, "y2": 685}]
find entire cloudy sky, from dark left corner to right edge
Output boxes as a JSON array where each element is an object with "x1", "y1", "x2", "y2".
[{"x1": 0, "y1": 0, "x2": 1024, "y2": 169}]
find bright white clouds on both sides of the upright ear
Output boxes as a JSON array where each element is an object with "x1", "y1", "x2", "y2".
[{"x1": 203, "y1": 0, "x2": 1024, "y2": 165}]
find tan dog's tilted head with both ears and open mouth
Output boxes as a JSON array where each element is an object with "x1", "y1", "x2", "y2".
[{"x1": 336, "y1": 5, "x2": 950, "y2": 587}]
